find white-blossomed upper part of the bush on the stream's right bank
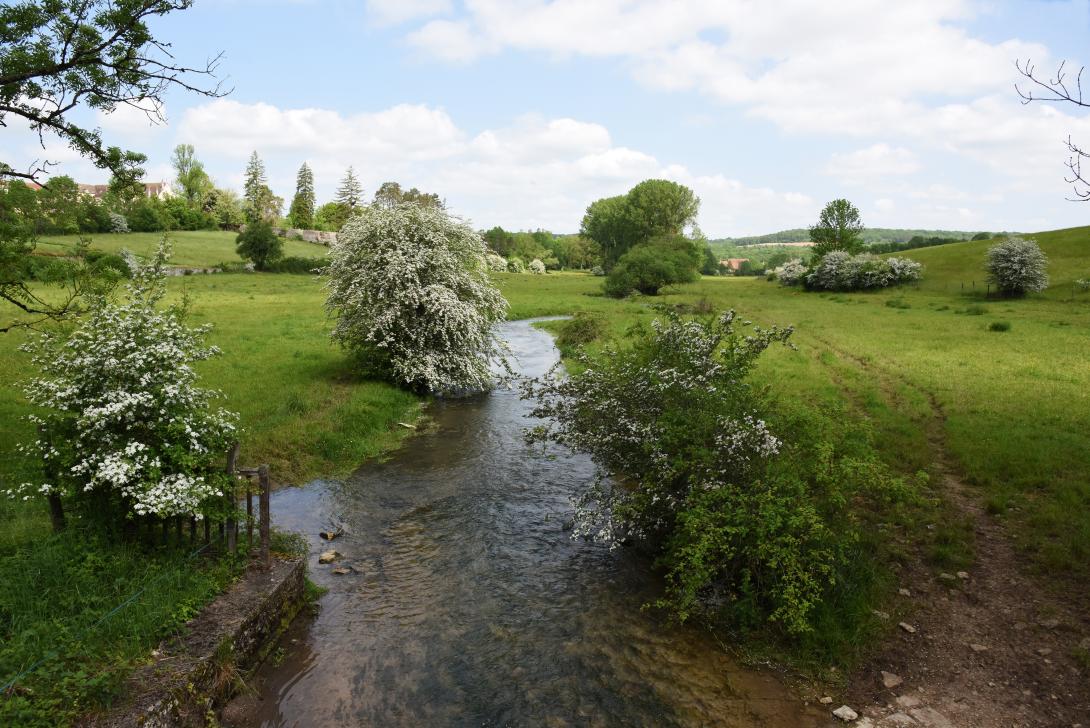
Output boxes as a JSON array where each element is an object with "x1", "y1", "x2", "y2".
[{"x1": 523, "y1": 312, "x2": 791, "y2": 546}]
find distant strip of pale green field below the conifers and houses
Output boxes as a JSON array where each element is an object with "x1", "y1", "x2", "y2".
[{"x1": 37, "y1": 230, "x2": 328, "y2": 268}]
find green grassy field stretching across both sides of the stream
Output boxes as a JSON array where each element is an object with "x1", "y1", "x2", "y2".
[{"x1": 0, "y1": 228, "x2": 1090, "y2": 723}]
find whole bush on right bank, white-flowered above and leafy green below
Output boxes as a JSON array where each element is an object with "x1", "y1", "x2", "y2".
[{"x1": 523, "y1": 310, "x2": 915, "y2": 635}]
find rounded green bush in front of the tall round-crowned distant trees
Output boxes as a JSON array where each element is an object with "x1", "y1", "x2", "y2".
[{"x1": 604, "y1": 235, "x2": 702, "y2": 299}]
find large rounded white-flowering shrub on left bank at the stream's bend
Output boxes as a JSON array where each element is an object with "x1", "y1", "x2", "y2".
[{"x1": 324, "y1": 205, "x2": 507, "y2": 393}]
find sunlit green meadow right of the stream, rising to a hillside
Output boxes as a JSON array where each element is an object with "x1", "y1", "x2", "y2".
[{"x1": 498, "y1": 228, "x2": 1090, "y2": 581}]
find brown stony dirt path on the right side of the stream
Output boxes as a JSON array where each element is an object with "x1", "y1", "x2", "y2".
[{"x1": 815, "y1": 342, "x2": 1090, "y2": 728}]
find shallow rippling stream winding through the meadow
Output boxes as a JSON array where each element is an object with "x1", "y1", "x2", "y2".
[{"x1": 253, "y1": 321, "x2": 823, "y2": 728}]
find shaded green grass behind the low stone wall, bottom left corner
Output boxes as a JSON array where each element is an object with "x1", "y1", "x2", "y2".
[{"x1": 0, "y1": 529, "x2": 238, "y2": 728}]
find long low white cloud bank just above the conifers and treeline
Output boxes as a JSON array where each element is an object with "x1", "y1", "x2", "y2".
[{"x1": 178, "y1": 99, "x2": 816, "y2": 235}]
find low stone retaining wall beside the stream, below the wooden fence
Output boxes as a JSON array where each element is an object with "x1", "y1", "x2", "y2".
[{"x1": 94, "y1": 559, "x2": 306, "y2": 728}]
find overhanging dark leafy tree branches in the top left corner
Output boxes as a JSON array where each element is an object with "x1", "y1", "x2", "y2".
[{"x1": 0, "y1": 0, "x2": 223, "y2": 329}]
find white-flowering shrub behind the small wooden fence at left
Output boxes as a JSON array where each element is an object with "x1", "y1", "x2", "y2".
[{"x1": 9, "y1": 242, "x2": 238, "y2": 519}]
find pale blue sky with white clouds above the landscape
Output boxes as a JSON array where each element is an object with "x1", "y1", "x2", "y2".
[{"x1": 6, "y1": 0, "x2": 1090, "y2": 238}]
